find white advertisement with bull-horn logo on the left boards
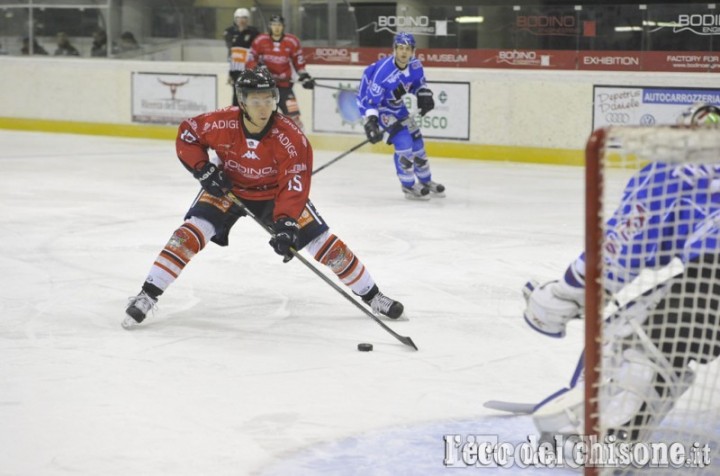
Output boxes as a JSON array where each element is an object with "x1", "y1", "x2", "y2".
[{"x1": 132, "y1": 72, "x2": 217, "y2": 124}]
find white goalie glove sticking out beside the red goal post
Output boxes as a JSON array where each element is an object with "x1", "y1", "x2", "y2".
[{"x1": 523, "y1": 280, "x2": 585, "y2": 337}]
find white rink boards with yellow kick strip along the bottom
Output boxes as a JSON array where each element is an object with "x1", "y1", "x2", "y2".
[{"x1": 0, "y1": 57, "x2": 717, "y2": 164}]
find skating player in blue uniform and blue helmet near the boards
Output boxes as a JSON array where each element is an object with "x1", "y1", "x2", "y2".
[{"x1": 357, "y1": 33, "x2": 445, "y2": 200}]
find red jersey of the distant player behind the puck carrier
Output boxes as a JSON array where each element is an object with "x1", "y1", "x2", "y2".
[{"x1": 246, "y1": 33, "x2": 305, "y2": 88}]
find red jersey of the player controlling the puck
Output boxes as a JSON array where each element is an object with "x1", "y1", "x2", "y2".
[{"x1": 175, "y1": 106, "x2": 313, "y2": 220}]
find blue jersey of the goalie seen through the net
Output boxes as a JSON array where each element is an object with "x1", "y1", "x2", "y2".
[{"x1": 565, "y1": 162, "x2": 720, "y2": 292}]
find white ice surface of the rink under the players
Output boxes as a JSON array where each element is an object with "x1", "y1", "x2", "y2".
[{"x1": 0, "y1": 131, "x2": 596, "y2": 476}]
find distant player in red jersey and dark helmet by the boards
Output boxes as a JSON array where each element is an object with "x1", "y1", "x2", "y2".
[{"x1": 247, "y1": 15, "x2": 315, "y2": 129}]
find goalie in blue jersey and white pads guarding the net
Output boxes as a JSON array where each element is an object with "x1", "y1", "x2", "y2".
[{"x1": 523, "y1": 104, "x2": 720, "y2": 450}]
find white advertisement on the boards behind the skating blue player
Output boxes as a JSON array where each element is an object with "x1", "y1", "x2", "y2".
[{"x1": 313, "y1": 78, "x2": 470, "y2": 140}]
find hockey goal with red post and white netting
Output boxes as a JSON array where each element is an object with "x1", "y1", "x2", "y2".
[{"x1": 585, "y1": 126, "x2": 720, "y2": 475}]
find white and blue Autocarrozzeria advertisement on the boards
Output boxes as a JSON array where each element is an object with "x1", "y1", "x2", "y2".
[{"x1": 593, "y1": 86, "x2": 720, "y2": 129}]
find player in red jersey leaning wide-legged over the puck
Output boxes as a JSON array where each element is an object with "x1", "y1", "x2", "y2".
[{"x1": 122, "y1": 68, "x2": 403, "y2": 328}]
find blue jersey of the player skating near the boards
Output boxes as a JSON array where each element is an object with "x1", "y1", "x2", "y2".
[{"x1": 357, "y1": 56, "x2": 427, "y2": 125}]
